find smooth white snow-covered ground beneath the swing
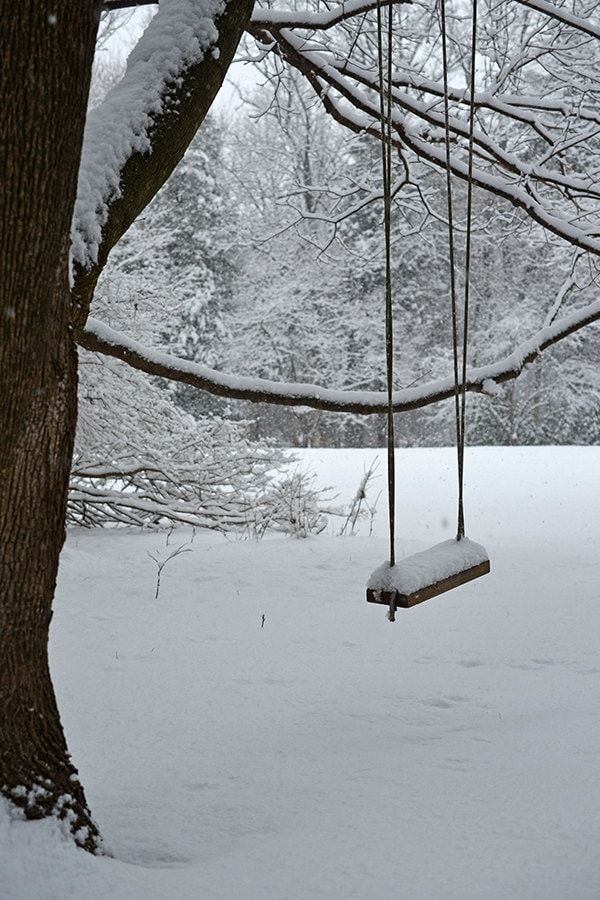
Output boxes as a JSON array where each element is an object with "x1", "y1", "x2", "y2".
[{"x1": 0, "y1": 448, "x2": 600, "y2": 900}]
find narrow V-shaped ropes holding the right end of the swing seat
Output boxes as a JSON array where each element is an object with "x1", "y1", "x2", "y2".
[{"x1": 440, "y1": 0, "x2": 477, "y2": 541}]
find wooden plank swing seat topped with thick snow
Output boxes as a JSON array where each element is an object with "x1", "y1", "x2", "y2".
[{"x1": 367, "y1": 538, "x2": 490, "y2": 609}]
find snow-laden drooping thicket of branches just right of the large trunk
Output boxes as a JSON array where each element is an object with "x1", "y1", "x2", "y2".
[{"x1": 75, "y1": 353, "x2": 329, "y2": 537}]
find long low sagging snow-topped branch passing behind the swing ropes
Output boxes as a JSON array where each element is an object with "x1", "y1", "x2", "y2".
[{"x1": 78, "y1": 300, "x2": 600, "y2": 415}]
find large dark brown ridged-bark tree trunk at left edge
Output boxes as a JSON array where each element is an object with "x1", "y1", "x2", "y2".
[{"x1": 0, "y1": 0, "x2": 99, "y2": 851}]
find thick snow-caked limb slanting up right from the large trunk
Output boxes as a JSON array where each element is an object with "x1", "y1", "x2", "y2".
[{"x1": 72, "y1": 0, "x2": 254, "y2": 331}]
